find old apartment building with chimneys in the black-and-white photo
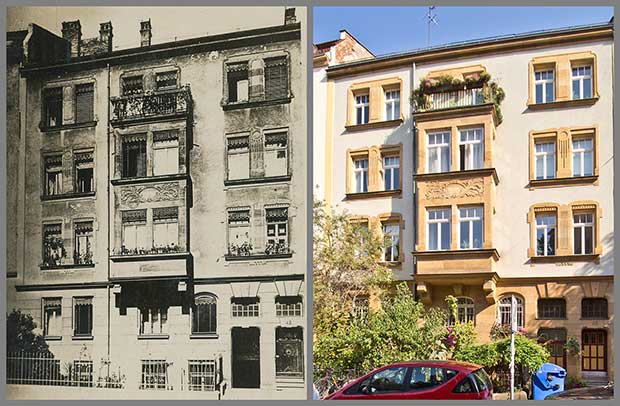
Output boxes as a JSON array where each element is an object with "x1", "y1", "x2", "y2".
[{"x1": 8, "y1": 9, "x2": 308, "y2": 399}]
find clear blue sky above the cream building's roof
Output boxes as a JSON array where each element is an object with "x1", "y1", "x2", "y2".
[{"x1": 314, "y1": 6, "x2": 614, "y2": 55}]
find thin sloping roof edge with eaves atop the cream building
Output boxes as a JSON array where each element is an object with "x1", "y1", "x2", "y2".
[{"x1": 328, "y1": 21, "x2": 613, "y2": 74}]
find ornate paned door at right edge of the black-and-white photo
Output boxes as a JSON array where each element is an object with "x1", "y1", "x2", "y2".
[{"x1": 276, "y1": 327, "x2": 304, "y2": 378}]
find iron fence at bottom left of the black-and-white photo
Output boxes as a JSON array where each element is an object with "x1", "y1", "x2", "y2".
[{"x1": 6, "y1": 352, "x2": 125, "y2": 389}]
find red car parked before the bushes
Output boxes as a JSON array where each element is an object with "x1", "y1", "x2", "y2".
[{"x1": 325, "y1": 361, "x2": 493, "y2": 400}]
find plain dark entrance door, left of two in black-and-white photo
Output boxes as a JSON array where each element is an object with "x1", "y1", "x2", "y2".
[{"x1": 232, "y1": 327, "x2": 260, "y2": 388}]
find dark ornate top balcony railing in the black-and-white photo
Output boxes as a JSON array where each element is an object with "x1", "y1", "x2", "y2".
[{"x1": 110, "y1": 85, "x2": 192, "y2": 122}]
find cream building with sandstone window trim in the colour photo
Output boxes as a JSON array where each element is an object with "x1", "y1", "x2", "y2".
[{"x1": 314, "y1": 23, "x2": 614, "y2": 381}]
